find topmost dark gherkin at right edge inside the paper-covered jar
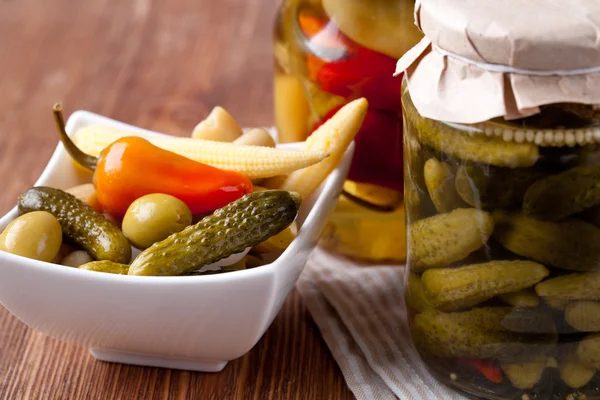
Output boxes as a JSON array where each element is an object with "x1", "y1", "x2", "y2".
[{"x1": 523, "y1": 165, "x2": 600, "y2": 221}]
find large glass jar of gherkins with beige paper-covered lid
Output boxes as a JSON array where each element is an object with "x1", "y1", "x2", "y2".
[{"x1": 398, "y1": 0, "x2": 600, "y2": 400}]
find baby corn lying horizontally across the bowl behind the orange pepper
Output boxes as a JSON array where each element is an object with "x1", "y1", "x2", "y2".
[{"x1": 73, "y1": 125, "x2": 328, "y2": 179}]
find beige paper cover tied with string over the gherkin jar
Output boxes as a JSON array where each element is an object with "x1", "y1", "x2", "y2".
[{"x1": 396, "y1": 0, "x2": 600, "y2": 124}]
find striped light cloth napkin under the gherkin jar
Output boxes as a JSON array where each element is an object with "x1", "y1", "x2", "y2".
[{"x1": 297, "y1": 249, "x2": 467, "y2": 400}]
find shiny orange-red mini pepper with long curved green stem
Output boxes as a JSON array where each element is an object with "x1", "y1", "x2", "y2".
[{"x1": 54, "y1": 104, "x2": 252, "y2": 218}]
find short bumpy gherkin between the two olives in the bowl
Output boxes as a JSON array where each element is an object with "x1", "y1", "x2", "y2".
[{"x1": 19, "y1": 187, "x2": 131, "y2": 263}]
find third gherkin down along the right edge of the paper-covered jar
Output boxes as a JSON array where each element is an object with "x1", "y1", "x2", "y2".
[{"x1": 535, "y1": 272, "x2": 600, "y2": 301}]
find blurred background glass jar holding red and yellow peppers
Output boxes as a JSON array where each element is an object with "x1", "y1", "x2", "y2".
[{"x1": 275, "y1": 0, "x2": 421, "y2": 261}]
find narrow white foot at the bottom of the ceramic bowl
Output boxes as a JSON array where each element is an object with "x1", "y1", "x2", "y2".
[{"x1": 88, "y1": 349, "x2": 227, "y2": 372}]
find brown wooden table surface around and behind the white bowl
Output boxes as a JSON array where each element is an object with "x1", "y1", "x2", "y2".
[{"x1": 0, "y1": 0, "x2": 352, "y2": 400}]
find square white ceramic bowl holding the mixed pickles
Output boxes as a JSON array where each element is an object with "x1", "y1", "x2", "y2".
[{"x1": 0, "y1": 111, "x2": 352, "y2": 372}]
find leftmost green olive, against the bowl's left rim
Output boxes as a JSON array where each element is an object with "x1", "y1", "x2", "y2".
[{"x1": 0, "y1": 211, "x2": 62, "y2": 262}]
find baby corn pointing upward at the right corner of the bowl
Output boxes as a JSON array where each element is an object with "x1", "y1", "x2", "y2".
[{"x1": 280, "y1": 98, "x2": 369, "y2": 199}]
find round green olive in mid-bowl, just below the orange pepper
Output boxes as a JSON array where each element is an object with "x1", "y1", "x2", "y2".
[{"x1": 123, "y1": 194, "x2": 192, "y2": 250}]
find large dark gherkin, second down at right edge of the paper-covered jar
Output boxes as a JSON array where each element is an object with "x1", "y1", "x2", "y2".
[{"x1": 493, "y1": 211, "x2": 600, "y2": 271}]
